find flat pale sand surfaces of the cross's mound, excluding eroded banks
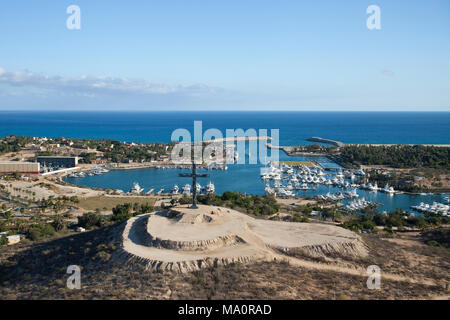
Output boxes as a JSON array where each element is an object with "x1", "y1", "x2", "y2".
[{"x1": 123, "y1": 206, "x2": 366, "y2": 262}]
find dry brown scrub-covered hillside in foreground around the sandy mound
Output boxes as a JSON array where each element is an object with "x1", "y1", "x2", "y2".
[{"x1": 0, "y1": 220, "x2": 450, "y2": 299}]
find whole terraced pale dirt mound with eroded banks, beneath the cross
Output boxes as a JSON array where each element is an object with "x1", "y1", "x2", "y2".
[{"x1": 122, "y1": 205, "x2": 367, "y2": 273}]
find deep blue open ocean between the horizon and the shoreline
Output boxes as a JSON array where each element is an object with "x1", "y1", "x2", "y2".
[{"x1": 0, "y1": 111, "x2": 450, "y2": 145}]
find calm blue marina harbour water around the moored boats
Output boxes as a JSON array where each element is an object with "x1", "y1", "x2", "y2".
[{"x1": 65, "y1": 153, "x2": 448, "y2": 212}]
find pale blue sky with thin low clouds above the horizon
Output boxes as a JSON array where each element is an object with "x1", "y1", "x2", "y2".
[{"x1": 0, "y1": 0, "x2": 450, "y2": 111}]
